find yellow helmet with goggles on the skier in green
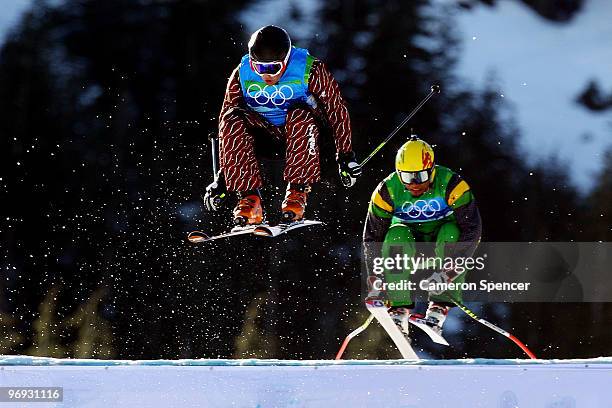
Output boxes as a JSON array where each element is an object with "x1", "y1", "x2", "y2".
[{"x1": 395, "y1": 135, "x2": 434, "y2": 184}]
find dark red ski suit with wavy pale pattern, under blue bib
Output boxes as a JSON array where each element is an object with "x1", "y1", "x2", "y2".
[{"x1": 219, "y1": 60, "x2": 351, "y2": 191}]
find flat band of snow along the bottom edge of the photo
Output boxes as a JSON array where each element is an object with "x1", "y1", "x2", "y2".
[{"x1": 0, "y1": 356, "x2": 612, "y2": 408}]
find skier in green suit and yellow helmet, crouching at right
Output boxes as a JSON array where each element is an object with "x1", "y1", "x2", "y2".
[{"x1": 363, "y1": 135, "x2": 482, "y2": 335}]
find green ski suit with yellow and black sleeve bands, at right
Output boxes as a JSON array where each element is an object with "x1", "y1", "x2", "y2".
[{"x1": 363, "y1": 165, "x2": 482, "y2": 306}]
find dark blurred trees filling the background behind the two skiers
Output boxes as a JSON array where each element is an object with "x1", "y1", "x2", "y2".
[{"x1": 0, "y1": 0, "x2": 612, "y2": 358}]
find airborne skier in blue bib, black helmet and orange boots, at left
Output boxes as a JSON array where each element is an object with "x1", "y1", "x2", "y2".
[{"x1": 204, "y1": 25, "x2": 361, "y2": 225}]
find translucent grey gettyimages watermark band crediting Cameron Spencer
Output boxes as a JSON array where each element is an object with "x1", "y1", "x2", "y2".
[{"x1": 362, "y1": 242, "x2": 612, "y2": 303}]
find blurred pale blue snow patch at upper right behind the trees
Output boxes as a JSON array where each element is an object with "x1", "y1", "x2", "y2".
[{"x1": 456, "y1": 0, "x2": 612, "y2": 190}]
